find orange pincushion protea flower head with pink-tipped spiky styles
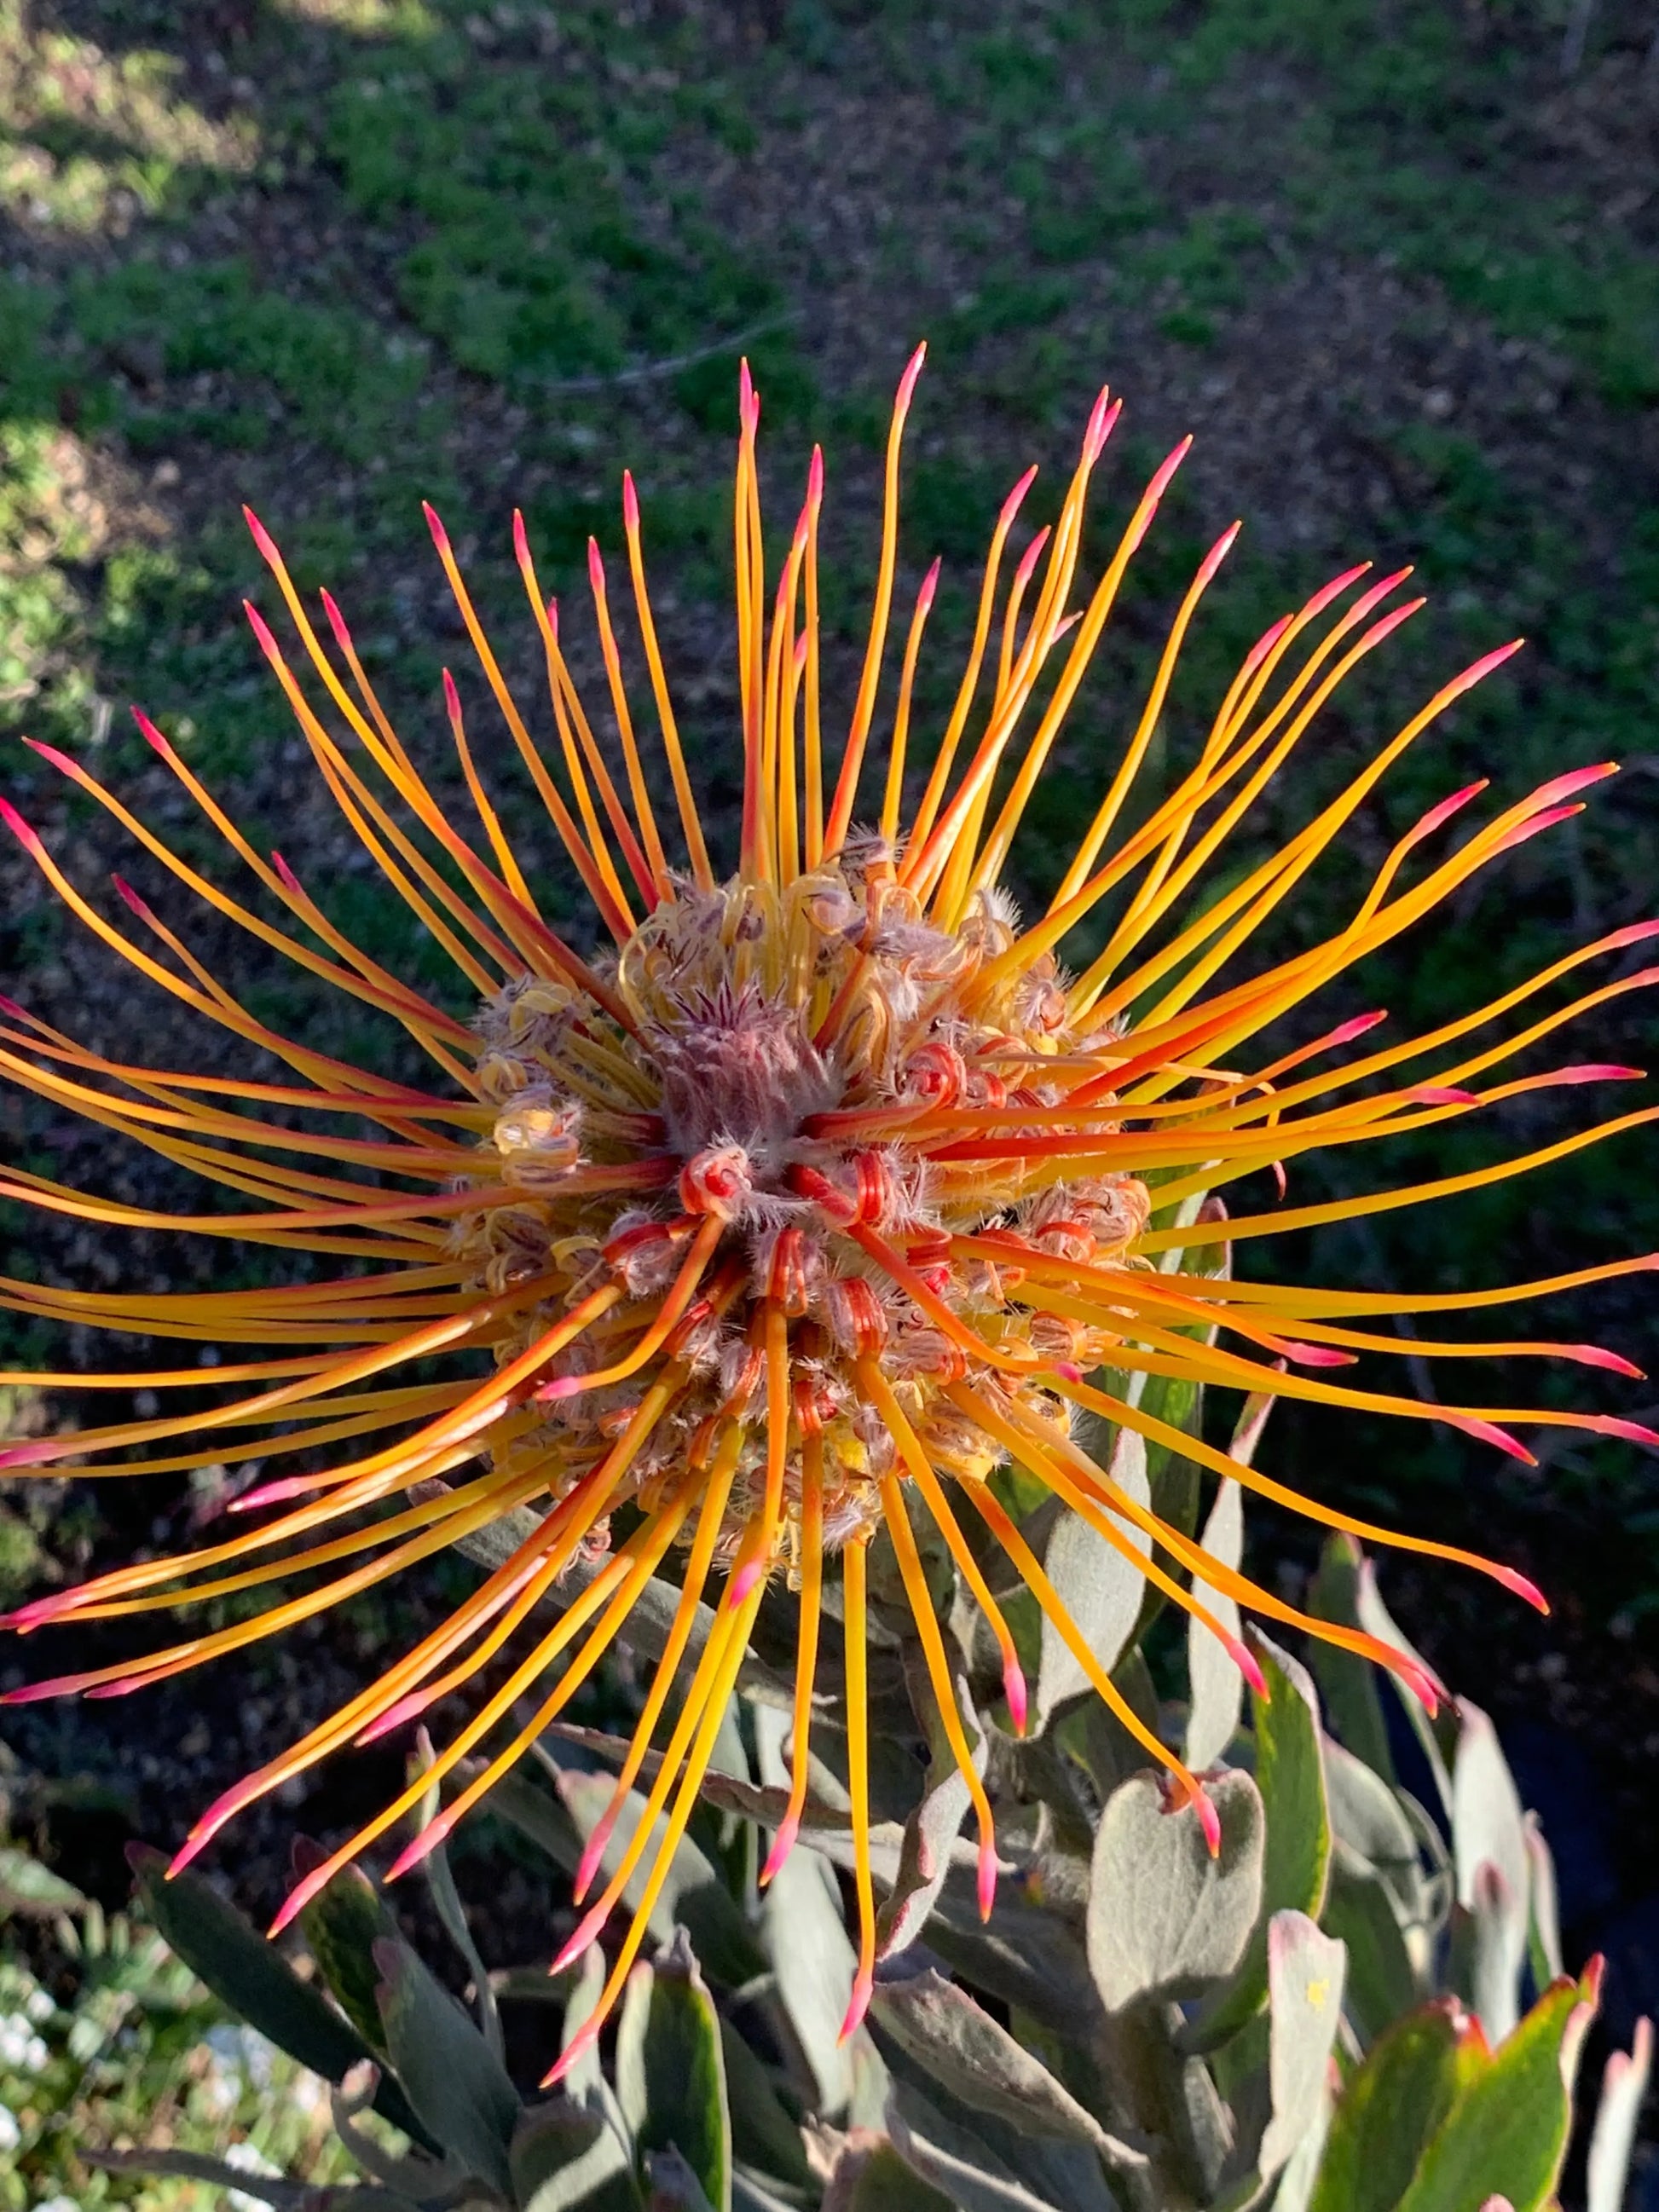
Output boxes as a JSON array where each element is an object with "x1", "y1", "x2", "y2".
[{"x1": 0, "y1": 352, "x2": 1659, "y2": 2064}]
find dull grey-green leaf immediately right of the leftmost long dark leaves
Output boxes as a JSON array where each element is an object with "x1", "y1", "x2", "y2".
[{"x1": 373, "y1": 1938, "x2": 522, "y2": 2190}]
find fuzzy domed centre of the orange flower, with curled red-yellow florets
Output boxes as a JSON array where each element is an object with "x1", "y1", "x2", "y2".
[{"x1": 460, "y1": 847, "x2": 1148, "y2": 1566}]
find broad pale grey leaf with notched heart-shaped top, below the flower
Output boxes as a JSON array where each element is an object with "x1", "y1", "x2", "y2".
[{"x1": 1089, "y1": 1770, "x2": 1265, "y2": 2013}]
